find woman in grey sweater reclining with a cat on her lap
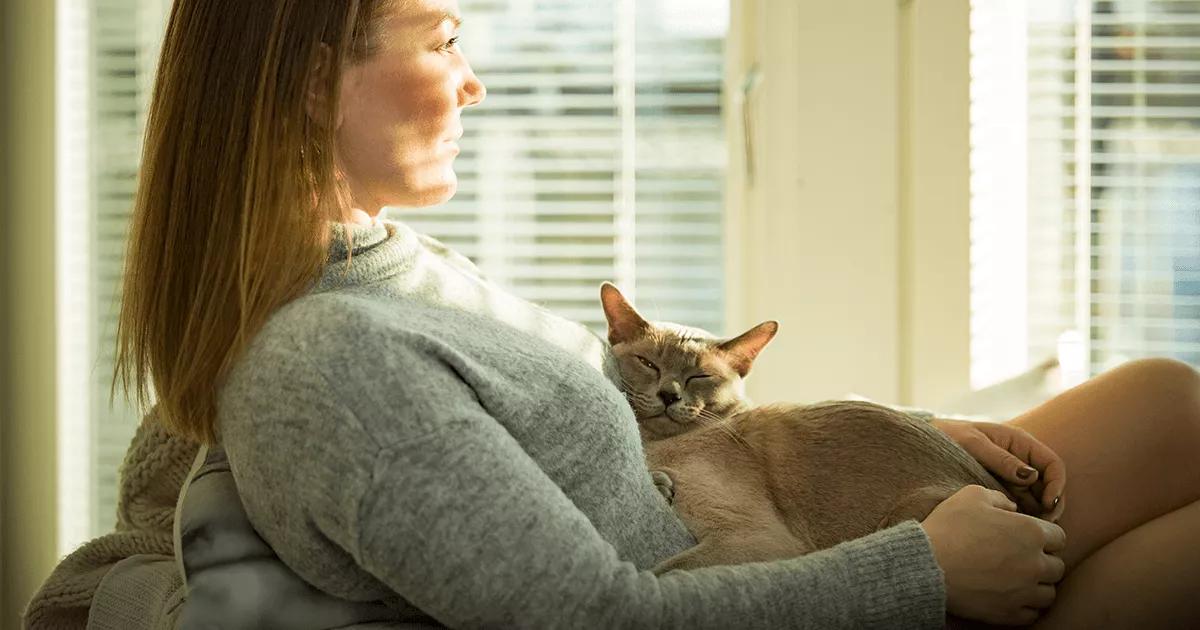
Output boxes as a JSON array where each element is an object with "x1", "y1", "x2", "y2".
[{"x1": 108, "y1": 0, "x2": 1200, "y2": 628}]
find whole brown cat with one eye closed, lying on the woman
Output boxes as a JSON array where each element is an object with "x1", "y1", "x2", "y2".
[{"x1": 600, "y1": 282, "x2": 1013, "y2": 574}]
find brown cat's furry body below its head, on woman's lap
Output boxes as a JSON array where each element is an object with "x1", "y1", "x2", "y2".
[{"x1": 643, "y1": 402, "x2": 1003, "y2": 572}]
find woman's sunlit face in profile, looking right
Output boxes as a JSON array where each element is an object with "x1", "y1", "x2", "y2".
[{"x1": 336, "y1": 0, "x2": 486, "y2": 216}]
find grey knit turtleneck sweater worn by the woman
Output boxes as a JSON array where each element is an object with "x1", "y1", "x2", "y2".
[{"x1": 218, "y1": 222, "x2": 944, "y2": 629}]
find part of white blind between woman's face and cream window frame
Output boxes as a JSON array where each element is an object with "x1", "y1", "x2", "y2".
[{"x1": 400, "y1": 0, "x2": 727, "y2": 331}]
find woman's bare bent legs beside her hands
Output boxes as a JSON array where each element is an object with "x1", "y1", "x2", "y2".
[{"x1": 1012, "y1": 359, "x2": 1200, "y2": 628}]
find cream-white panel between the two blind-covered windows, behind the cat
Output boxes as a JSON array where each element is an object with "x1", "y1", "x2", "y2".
[{"x1": 727, "y1": 0, "x2": 970, "y2": 404}]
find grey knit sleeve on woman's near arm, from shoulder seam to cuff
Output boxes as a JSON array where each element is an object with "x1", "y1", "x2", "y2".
[{"x1": 355, "y1": 398, "x2": 943, "y2": 629}]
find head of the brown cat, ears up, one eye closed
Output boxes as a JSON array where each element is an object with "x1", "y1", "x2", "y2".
[{"x1": 600, "y1": 282, "x2": 779, "y2": 439}]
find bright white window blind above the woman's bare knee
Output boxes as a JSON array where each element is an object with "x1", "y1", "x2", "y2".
[{"x1": 971, "y1": 0, "x2": 1200, "y2": 385}]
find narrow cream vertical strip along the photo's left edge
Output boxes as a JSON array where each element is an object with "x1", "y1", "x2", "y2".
[{"x1": 0, "y1": 0, "x2": 55, "y2": 629}]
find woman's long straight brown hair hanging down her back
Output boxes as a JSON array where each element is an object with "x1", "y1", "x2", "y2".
[{"x1": 113, "y1": 0, "x2": 391, "y2": 444}]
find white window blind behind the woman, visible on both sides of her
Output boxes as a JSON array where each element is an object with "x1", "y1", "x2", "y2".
[{"x1": 59, "y1": 0, "x2": 728, "y2": 544}]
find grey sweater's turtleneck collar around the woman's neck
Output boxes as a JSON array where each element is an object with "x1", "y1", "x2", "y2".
[{"x1": 312, "y1": 220, "x2": 421, "y2": 293}]
